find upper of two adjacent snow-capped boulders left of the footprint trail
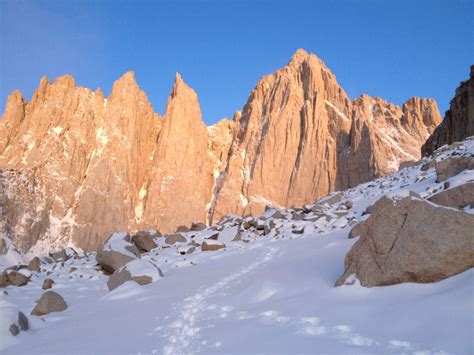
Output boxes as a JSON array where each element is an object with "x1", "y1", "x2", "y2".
[{"x1": 96, "y1": 232, "x2": 140, "y2": 273}]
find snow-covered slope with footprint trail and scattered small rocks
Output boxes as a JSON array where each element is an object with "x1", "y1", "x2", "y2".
[{"x1": 0, "y1": 139, "x2": 474, "y2": 354}]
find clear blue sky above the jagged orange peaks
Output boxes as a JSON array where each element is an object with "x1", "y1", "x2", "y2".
[{"x1": 0, "y1": 0, "x2": 474, "y2": 123}]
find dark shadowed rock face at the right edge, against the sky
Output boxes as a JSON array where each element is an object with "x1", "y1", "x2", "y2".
[{"x1": 421, "y1": 65, "x2": 474, "y2": 156}]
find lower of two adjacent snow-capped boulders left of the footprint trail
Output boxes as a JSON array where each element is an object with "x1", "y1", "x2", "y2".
[{"x1": 107, "y1": 260, "x2": 163, "y2": 291}]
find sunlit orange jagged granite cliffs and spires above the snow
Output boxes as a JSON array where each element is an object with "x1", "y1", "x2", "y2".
[{"x1": 0, "y1": 50, "x2": 441, "y2": 252}]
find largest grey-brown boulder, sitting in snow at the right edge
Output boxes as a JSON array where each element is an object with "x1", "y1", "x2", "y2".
[{"x1": 336, "y1": 194, "x2": 474, "y2": 287}]
